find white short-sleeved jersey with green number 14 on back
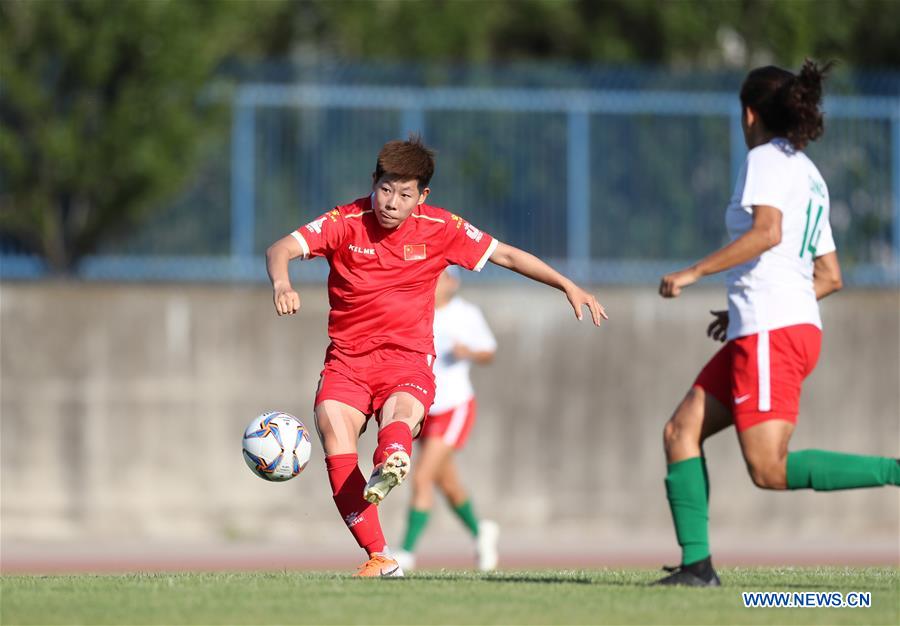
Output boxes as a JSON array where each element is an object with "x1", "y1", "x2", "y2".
[{"x1": 725, "y1": 137, "x2": 835, "y2": 339}]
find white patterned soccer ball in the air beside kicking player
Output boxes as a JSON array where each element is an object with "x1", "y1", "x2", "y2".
[{"x1": 244, "y1": 411, "x2": 312, "y2": 482}]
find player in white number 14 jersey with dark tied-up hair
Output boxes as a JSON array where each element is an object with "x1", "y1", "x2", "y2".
[{"x1": 658, "y1": 60, "x2": 900, "y2": 586}]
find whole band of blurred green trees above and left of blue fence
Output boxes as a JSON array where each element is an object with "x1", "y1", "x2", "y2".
[{"x1": 0, "y1": 0, "x2": 900, "y2": 272}]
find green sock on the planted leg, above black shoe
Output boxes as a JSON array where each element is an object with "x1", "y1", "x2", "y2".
[{"x1": 666, "y1": 456, "x2": 709, "y2": 565}]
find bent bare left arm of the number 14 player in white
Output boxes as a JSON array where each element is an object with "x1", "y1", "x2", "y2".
[{"x1": 659, "y1": 204, "x2": 781, "y2": 298}]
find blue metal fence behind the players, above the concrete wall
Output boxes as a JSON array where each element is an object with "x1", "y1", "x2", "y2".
[{"x1": 0, "y1": 77, "x2": 900, "y2": 285}]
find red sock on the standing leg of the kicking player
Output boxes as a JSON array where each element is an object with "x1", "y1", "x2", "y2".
[{"x1": 325, "y1": 450, "x2": 388, "y2": 554}]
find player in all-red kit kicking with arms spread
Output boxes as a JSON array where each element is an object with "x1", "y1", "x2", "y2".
[{"x1": 266, "y1": 137, "x2": 606, "y2": 576}]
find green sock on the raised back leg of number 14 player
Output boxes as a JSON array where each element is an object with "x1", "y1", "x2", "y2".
[{"x1": 787, "y1": 450, "x2": 900, "y2": 491}]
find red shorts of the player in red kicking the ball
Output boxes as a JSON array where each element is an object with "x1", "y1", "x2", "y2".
[{"x1": 316, "y1": 344, "x2": 434, "y2": 415}]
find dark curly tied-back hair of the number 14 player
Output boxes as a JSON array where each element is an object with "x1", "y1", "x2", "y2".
[{"x1": 741, "y1": 59, "x2": 834, "y2": 150}]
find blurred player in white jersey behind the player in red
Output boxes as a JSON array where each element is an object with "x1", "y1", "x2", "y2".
[{"x1": 395, "y1": 266, "x2": 499, "y2": 571}]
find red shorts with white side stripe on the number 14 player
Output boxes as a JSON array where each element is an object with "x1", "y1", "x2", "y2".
[{"x1": 694, "y1": 324, "x2": 822, "y2": 432}]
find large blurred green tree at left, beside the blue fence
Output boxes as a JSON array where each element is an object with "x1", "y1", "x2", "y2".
[{"x1": 0, "y1": 0, "x2": 281, "y2": 272}]
